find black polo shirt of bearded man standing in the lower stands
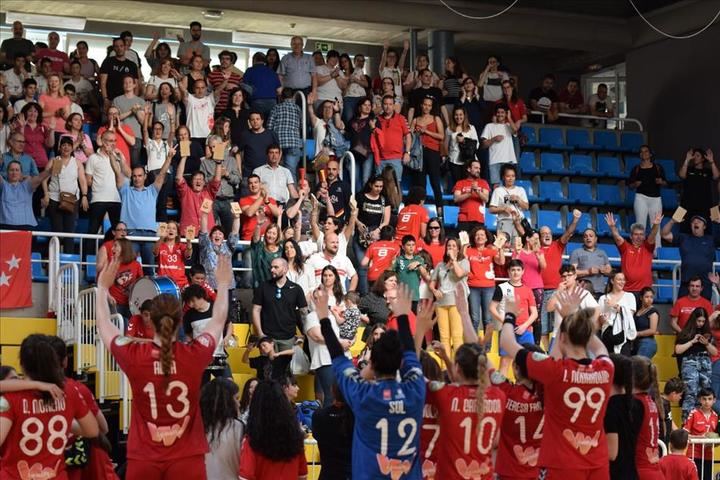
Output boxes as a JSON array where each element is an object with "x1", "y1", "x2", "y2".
[{"x1": 253, "y1": 280, "x2": 307, "y2": 340}]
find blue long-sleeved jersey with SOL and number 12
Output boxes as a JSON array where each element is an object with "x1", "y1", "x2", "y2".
[{"x1": 333, "y1": 351, "x2": 425, "y2": 480}]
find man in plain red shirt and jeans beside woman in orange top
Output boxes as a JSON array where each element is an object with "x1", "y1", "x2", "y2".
[{"x1": 370, "y1": 95, "x2": 412, "y2": 189}]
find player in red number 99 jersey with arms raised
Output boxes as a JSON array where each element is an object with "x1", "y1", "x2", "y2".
[{"x1": 500, "y1": 287, "x2": 614, "y2": 480}]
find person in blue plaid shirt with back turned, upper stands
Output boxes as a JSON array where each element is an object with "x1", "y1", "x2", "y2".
[{"x1": 270, "y1": 87, "x2": 303, "y2": 179}]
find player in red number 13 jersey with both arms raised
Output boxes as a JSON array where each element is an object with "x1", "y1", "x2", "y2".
[{"x1": 97, "y1": 256, "x2": 232, "y2": 480}]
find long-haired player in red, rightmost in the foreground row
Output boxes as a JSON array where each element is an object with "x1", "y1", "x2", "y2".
[{"x1": 632, "y1": 355, "x2": 665, "y2": 480}]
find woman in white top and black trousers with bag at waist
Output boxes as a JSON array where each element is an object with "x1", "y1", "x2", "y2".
[{"x1": 42, "y1": 137, "x2": 89, "y2": 253}]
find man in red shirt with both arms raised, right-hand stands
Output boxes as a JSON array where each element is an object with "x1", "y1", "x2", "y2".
[{"x1": 605, "y1": 213, "x2": 662, "y2": 293}]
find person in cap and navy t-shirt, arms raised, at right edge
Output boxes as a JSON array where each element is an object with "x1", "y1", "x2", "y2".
[{"x1": 661, "y1": 215, "x2": 720, "y2": 300}]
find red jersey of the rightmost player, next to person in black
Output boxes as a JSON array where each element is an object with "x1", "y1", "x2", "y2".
[{"x1": 635, "y1": 392, "x2": 663, "y2": 480}]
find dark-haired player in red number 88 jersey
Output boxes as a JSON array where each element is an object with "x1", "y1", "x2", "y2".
[{"x1": 0, "y1": 334, "x2": 99, "y2": 480}]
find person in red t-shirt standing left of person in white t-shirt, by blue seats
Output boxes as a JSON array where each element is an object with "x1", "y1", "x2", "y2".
[{"x1": 453, "y1": 159, "x2": 490, "y2": 232}]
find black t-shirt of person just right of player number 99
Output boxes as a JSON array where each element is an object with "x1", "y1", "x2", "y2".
[{"x1": 605, "y1": 395, "x2": 643, "y2": 480}]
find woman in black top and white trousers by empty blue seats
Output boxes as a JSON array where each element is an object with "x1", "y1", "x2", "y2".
[{"x1": 628, "y1": 145, "x2": 667, "y2": 247}]
